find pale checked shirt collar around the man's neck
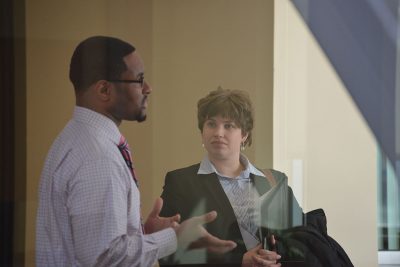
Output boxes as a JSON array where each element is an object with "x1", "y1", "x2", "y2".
[{"x1": 73, "y1": 106, "x2": 121, "y2": 145}]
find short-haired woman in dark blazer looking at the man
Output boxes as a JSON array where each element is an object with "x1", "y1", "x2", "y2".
[{"x1": 161, "y1": 88, "x2": 299, "y2": 267}]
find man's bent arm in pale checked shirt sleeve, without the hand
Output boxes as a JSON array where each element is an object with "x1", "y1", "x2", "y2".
[{"x1": 67, "y1": 159, "x2": 177, "y2": 266}]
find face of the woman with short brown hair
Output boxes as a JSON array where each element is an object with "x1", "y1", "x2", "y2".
[{"x1": 202, "y1": 115, "x2": 247, "y2": 160}]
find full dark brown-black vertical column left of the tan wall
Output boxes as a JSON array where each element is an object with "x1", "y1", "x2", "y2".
[{"x1": 0, "y1": 0, "x2": 26, "y2": 266}]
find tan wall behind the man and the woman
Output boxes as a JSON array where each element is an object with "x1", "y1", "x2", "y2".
[{"x1": 25, "y1": 0, "x2": 273, "y2": 266}]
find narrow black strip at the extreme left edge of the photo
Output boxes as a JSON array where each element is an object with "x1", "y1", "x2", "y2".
[{"x1": 0, "y1": 0, "x2": 14, "y2": 266}]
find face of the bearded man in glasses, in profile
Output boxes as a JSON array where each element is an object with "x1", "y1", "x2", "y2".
[{"x1": 110, "y1": 52, "x2": 152, "y2": 122}]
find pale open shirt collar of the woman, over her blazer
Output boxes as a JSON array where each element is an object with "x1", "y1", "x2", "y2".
[{"x1": 197, "y1": 154, "x2": 265, "y2": 179}]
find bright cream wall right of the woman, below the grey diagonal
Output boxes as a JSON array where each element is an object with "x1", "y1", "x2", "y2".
[{"x1": 274, "y1": 0, "x2": 378, "y2": 267}]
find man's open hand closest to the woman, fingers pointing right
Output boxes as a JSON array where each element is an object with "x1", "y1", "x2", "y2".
[{"x1": 175, "y1": 211, "x2": 236, "y2": 254}]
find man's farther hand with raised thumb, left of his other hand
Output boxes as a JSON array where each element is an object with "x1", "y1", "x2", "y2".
[{"x1": 144, "y1": 197, "x2": 181, "y2": 234}]
